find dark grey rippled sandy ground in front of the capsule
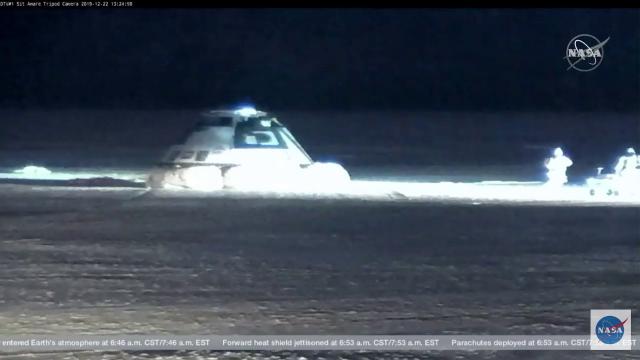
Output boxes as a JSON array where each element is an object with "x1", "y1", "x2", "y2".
[{"x1": 0, "y1": 184, "x2": 640, "y2": 359}]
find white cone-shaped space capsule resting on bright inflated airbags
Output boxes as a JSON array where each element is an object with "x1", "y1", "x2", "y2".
[{"x1": 147, "y1": 107, "x2": 350, "y2": 191}]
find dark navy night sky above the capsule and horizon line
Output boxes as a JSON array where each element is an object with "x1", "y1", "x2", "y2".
[{"x1": 0, "y1": 9, "x2": 640, "y2": 111}]
